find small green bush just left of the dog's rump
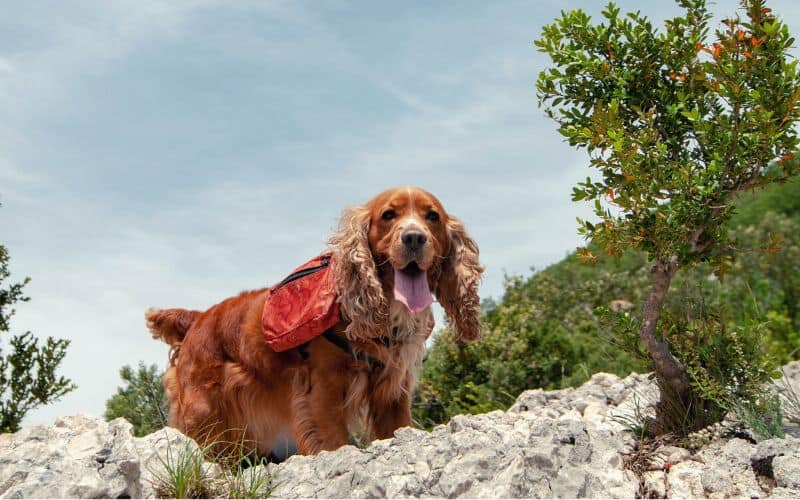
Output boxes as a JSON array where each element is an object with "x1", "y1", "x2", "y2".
[{"x1": 104, "y1": 361, "x2": 169, "y2": 436}]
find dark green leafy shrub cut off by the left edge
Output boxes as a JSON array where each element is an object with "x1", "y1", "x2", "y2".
[{"x1": 0, "y1": 240, "x2": 75, "y2": 432}]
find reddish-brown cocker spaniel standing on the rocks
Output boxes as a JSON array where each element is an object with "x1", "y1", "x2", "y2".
[{"x1": 145, "y1": 188, "x2": 484, "y2": 455}]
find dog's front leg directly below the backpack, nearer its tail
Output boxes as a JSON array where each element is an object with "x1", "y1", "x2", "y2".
[{"x1": 292, "y1": 367, "x2": 349, "y2": 455}]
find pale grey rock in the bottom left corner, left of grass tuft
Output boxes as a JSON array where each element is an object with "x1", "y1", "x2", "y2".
[{"x1": 0, "y1": 415, "x2": 212, "y2": 498}]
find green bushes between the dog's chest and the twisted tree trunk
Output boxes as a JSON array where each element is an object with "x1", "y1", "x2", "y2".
[{"x1": 414, "y1": 254, "x2": 646, "y2": 427}]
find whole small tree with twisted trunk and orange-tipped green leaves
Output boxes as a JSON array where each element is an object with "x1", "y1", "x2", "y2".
[{"x1": 535, "y1": 0, "x2": 800, "y2": 431}]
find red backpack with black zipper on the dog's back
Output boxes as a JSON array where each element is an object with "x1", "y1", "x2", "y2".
[{"x1": 261, "y1": 253, "x2": 341, "y2": 352}]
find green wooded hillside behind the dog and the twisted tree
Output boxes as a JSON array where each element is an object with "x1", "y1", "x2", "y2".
[{"x1": 414, "y1": 179, "x2": 800, "y2": 427}]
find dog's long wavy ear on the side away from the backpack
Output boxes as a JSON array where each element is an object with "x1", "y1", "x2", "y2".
[{"x1": 436, "y1": 216, "x2": 483, "y2": 340}]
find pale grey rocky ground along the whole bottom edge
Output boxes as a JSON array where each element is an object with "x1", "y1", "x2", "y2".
[{"x1": 0, "y1": 362, "x2": 800, "y2": 498}]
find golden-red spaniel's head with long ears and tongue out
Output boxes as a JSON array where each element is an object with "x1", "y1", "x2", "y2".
[{"x1": 330, "y1": 188, "x2": 483, "y2": 340}]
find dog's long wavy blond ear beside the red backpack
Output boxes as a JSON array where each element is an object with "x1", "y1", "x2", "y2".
[{"x1": 328, "y1": 206, "x2": 389, "y2": 339}]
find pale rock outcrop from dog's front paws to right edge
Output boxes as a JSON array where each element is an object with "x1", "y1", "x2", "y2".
[{"x1": 274, "y1": 363, "x2": 800, "y2": 498}]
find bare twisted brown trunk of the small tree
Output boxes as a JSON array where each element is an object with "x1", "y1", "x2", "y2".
[{"x1": 639, "y1": 257, "x2": 691, "y2": 434}]
